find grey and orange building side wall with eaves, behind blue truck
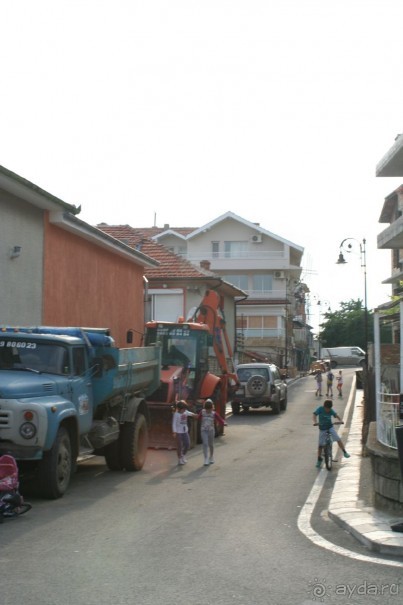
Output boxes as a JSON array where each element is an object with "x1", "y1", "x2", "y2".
[{"x1": 0, "y1": 167, "x2": 158, "y2": 346}]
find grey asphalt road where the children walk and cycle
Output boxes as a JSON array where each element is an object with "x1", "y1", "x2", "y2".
[{"x1": 0, "y1": 370, "x2": 403, "y2": 605}]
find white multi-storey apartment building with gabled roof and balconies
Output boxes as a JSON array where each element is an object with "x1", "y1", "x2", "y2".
[{"x1": 137, "y1": 212, "x2": 311, "y2": 369}]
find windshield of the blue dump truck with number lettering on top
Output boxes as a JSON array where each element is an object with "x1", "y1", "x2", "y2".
[{"x1": 0, "y1": 337, "x2": 70, "y2": 374}]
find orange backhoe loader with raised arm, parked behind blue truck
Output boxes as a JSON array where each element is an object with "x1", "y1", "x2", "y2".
[{"x1": 145, "y1": 290, "x2": 238, "y2": 449}]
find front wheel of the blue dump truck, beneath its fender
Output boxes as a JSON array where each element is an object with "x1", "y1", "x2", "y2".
[{"x1": 39, "y1": 426, "x2": 73, "y2": 500}]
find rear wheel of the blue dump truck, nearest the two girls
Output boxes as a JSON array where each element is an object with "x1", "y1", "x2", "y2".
[{"x1": 119, "y1": 414, "x2": 148, "y2": 471}]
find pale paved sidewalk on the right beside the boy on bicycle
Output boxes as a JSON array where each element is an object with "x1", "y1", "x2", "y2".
[{"x1": 329, "y1": 391, "x2": 403, "y2": 556}]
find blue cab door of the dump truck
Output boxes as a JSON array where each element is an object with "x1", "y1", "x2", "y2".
[{"x1": 71, "y1": 347, "x2": 94, "y2": 433}]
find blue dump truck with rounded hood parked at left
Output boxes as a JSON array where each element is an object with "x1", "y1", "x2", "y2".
[{"x1": 0, "y1": 327, "x2": 161, "y2": 499}]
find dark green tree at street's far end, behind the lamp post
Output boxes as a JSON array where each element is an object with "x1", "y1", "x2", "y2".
[{"x1": 319, "y1": 299, "x2": 373, "y2": 351}]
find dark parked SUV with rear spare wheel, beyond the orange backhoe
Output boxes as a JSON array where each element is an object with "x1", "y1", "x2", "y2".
[{"x1": 231, "y1": 362, "x2": 287, "y2": 414}]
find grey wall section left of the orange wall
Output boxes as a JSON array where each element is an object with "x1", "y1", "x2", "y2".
[{"x1": 0, "y1": 190, "x2": 44, "y2": 326}]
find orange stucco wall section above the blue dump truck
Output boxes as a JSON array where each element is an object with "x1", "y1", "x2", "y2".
[{"x1": 43, "y1": 216, "x2": 144, "y2": 347}]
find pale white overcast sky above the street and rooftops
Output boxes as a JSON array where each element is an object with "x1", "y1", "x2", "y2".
[{"x1": 0, "y1": 0, "x2": 403, "y2": 330}]
